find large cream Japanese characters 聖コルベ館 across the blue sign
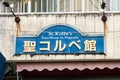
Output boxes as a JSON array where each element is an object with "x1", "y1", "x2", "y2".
[{"x1": 24, "y1": 40, "x2": 96, "y2": 52}]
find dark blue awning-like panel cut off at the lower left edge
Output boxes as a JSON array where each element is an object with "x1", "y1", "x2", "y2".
[{"x1": 0, "y1": 52, "x2": 6, "y2": 80}]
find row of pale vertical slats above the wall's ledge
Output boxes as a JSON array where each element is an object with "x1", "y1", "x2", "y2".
[{"x1": 0, "y1": 0, "x2": 120, "y2": 13}]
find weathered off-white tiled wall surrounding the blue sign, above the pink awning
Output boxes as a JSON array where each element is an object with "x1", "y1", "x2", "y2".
[{"x1": 0, "y1": 13, "x2": 120, "y2": 61}]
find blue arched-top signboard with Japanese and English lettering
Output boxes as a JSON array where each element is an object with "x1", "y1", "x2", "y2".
[{"x1": 15, "y1": 25, "x2": 104, "y2": 54}]
